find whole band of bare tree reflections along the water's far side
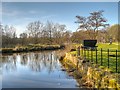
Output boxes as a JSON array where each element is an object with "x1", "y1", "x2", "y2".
[{"x1": 2, "y1": 51, "x2": 59, "y2": 73}]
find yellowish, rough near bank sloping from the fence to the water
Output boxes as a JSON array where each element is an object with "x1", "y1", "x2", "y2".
[{"x1": 61, "y1": 53, "x2": 120, "y2": 89}]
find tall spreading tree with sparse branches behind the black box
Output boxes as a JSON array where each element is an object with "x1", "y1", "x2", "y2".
[{"x1": 76, "y1": 10, "x2": 109, "y2": 39}]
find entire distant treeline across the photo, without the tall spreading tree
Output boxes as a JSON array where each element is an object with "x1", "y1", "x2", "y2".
[{"x1": 0, "y1": 21, "x2": 120, "y2": 48}]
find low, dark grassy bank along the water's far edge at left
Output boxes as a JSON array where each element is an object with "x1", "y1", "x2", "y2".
[{"x1": 0, "y1": 44, "x2": 65, "y2": 53}]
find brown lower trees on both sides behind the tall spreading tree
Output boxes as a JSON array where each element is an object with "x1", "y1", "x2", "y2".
[{"x1": 71, "y1": 24, "x2": 120, "y2": 43}]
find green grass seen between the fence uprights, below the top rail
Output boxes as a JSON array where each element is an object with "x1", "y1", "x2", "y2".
[{"x1": 86, "y1": 50, "x2": 120, "y2": 72}]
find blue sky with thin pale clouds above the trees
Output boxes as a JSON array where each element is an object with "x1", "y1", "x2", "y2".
[{"x1": 2, "y1": 2, "x2": 118, "y2": 34}]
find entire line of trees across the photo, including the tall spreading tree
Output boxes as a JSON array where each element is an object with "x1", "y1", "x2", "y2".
[{"x1": 0, "y1": 10, "x2": 120, "y2": 47}]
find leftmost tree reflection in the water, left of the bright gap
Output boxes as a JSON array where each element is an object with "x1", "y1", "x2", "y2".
[{"x1": 2, "y1": 55, "x2": 17, "y2": 71}]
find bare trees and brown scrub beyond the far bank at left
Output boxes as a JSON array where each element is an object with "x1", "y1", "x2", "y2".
[{"x1": 0, "y1": 21, "x2": 71, "y2": 47}]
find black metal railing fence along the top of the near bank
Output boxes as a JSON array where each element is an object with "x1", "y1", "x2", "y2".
[{"x1": 78, "y1": 48, "x2": 120, "y2": 73}]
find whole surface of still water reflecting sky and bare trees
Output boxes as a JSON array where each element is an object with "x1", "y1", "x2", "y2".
[{"x1": 2, "y1": 51, "x2": 77, "y2": 88}]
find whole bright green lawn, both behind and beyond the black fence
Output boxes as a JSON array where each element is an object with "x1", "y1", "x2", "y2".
[{"x1": 71, "y1": 43, "x2": 120, "y2": 72}]
